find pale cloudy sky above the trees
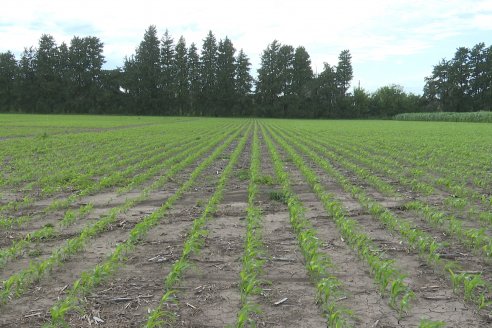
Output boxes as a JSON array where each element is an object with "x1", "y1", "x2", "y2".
[{"x1": 0, "y1": 0, "x2": 492, "y2": 94}]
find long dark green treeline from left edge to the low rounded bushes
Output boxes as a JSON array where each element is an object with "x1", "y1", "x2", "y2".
[{"x1": 0, "y1": 26, "x2": 426, "y2": 118}]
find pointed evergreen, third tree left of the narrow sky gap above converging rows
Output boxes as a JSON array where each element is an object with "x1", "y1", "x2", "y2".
[{"x1": 200, "y1": 31, "x2": 217, "y2": 116}]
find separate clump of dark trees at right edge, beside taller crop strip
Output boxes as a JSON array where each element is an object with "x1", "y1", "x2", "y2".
[{"x1": 424, "y1": 43, "x2": 492, "y2": 112}]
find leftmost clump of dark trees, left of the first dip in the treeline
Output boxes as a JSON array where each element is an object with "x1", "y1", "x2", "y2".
[{"x1": 0, "y1": 35, "x2": 112, "y2": 113}]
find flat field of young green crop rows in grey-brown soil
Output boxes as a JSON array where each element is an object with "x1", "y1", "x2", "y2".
[{"x1": 0, "y1": 115, "x2": 492, "y2": 327}]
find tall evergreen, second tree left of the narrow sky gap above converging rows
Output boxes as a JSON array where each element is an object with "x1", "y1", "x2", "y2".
[{"x1": 215, "y1": 37, "x2": 236, "y2": 116}]
